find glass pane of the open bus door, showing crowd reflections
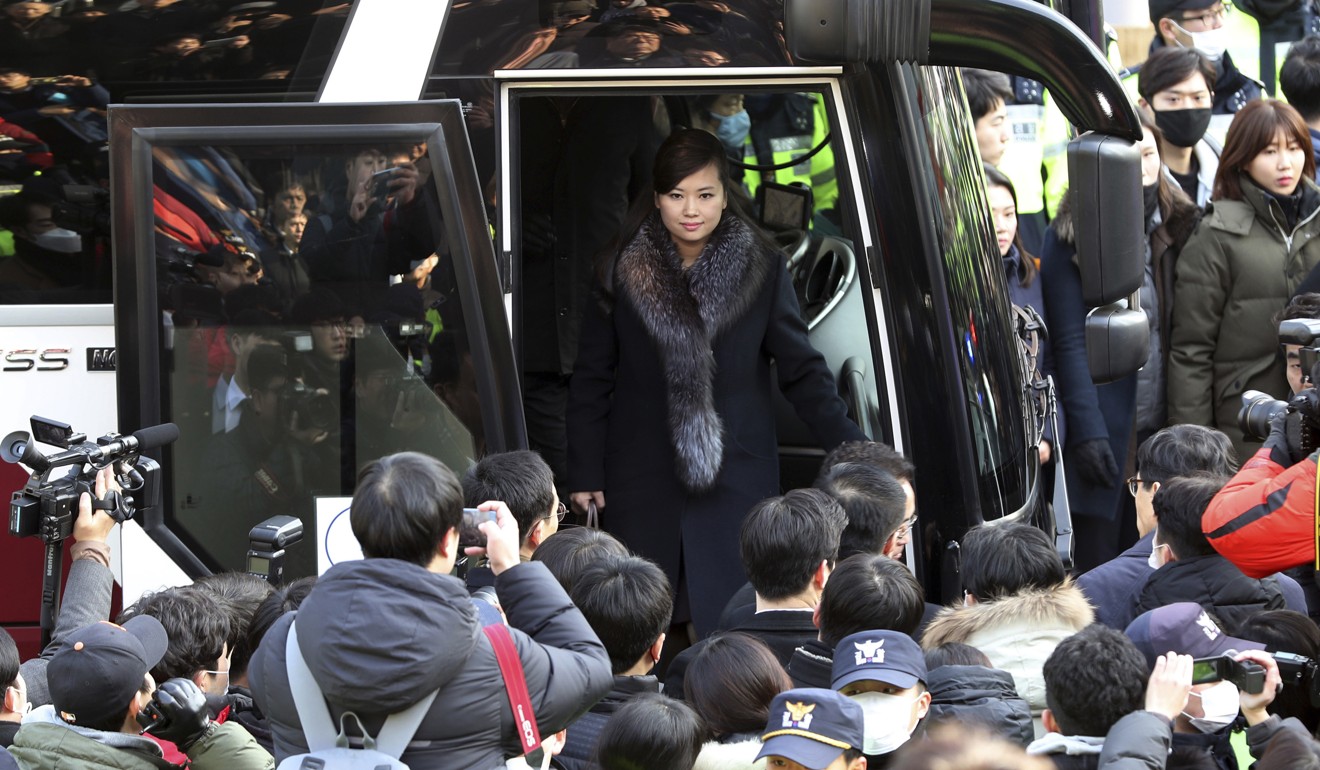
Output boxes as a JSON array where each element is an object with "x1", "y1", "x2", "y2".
[{"x1": 152, "y1": 143, "x2": 486, "y2": 575}]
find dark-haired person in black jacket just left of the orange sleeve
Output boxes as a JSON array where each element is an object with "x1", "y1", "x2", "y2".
[{"x1": 1137, "y1": 477, "x2": 1284, "y2": 627}]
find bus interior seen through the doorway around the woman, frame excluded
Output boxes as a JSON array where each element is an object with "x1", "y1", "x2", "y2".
[{"x1": 511, "y1": 82, "x2": 880, "y2": 485}]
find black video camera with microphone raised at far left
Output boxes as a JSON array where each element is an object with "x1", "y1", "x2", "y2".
[{"x1": 0, "y1": 415, "x2": 178, "y2": 544}]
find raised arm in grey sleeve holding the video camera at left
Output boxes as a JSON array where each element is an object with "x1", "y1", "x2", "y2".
[{"x1": 20, "y1": 468, "x2": 120, "y2": 708}]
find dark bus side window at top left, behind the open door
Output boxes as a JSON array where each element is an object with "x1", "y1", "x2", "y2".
[{"x1": 0, "y1": 0, "x2": 351, "y2": 304}]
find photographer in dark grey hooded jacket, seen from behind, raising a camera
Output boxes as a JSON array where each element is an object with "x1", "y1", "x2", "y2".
[{"x1": 248, "y1": 452, "x2": 612, "y2": 770}]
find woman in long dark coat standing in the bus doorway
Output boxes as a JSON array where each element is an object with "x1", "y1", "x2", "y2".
[{"x1": 568, "y1": 129, "x2": 866, "y2": 634}]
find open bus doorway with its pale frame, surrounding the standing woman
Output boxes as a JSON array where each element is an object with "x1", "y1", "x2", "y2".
[{"x1": 495, "y1": 73, "x2": 902, "y2": 489}]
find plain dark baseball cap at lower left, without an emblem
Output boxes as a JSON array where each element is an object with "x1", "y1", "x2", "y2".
[{"x1": 46, "y1": 615, "x2": 169, "y2": 726}]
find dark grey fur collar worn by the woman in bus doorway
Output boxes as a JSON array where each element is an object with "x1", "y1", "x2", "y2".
[{"x1": 614, "y1": 213, "x2": 775, "y2": 493}]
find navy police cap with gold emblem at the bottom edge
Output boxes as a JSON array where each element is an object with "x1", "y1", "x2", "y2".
[{"x1": 756, "y1": 687, "x2": 862, "y2": 770}]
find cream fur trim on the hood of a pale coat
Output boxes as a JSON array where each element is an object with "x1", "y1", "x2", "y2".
[{"x1": 921, "y1": 577, "x2": 1096, "y2": 650}]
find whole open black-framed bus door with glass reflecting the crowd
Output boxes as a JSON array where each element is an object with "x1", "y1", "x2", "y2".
[{"x1": 110, "y1": 100, "x2": 524, "y2": 580}]
